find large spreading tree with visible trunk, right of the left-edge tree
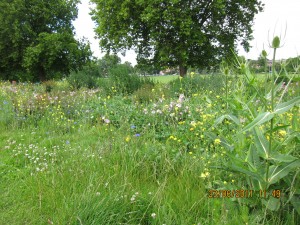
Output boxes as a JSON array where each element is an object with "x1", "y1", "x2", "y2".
[{"x1": 91, "y1": 0, "x2": 263, "y2": 76}]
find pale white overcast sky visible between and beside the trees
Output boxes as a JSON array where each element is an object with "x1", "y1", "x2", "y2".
[{"x1": 73, "y1": 0, "x2": 300, "y2": 65}]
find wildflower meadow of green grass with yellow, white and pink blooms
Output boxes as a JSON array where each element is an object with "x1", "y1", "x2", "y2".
[{"x1": 0, "y1": 71, "x2": 300, "y2": 225}]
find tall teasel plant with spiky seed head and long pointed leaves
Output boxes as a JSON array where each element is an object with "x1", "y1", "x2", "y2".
[{"x1": 209, "y1": 47, "x2": 300, "y2": 218}]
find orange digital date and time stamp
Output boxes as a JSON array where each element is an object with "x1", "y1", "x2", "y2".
[{"x1": 207, "y1": 189, "x2": 281, "y2": 198}]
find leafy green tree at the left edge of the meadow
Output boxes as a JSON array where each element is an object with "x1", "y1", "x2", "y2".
[{"x1": 0, "y1": 0, "x2": 91, "y2": 81}]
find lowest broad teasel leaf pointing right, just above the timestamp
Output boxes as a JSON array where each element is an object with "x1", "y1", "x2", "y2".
[{"x1": 268, "y1": 159, "x2": 300, "y2": 185}]
